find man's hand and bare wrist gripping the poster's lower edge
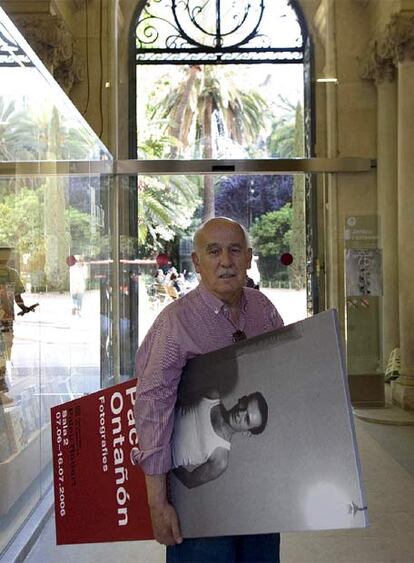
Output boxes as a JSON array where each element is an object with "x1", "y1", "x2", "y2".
[{"x1": 145, "y1": 475, "x2": 183, "y2": 545}]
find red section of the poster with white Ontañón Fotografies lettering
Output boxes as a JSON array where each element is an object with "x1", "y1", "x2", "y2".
[{"x1": 51, "y1": 379, "x2": 154, "y2": 544}]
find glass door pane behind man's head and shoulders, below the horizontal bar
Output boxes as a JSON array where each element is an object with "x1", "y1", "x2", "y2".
[{"x1": 133, "y1": 174, "x2": 306, "y2": 341}]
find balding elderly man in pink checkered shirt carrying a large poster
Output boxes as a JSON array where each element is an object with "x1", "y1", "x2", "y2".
[{"x1": 135, "y1": 217, "x2": 283, "y2": 563}]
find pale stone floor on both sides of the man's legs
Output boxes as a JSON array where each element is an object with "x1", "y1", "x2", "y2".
[{"x1": 19, "y1": 396, "x2": 414, "y2": 563}]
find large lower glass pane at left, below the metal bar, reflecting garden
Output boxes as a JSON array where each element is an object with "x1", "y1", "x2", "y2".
[{"x1": 0, "y1": 173, "x2": 112, "y2": 543}]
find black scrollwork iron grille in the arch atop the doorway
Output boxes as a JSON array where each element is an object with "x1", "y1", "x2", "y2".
[{"x1": 136, "y1": 0, "x2": 306, "y2": 64}]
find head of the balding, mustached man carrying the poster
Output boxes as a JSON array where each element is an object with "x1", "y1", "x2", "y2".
[{"x1": 192, "y1": 219, "x2": 252, "y2": 303}]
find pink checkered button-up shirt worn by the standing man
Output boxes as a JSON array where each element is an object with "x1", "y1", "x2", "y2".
[{"x1": 134, "y1": 284, "x2": 283, "y2": 475}]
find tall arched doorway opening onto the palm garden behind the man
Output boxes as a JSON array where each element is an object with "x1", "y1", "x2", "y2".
[{"x1": 128, "y1": 1, "x2": 314, "y2": 352}]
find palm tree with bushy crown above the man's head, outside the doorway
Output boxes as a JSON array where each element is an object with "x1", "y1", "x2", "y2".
[{"x1": 154, "y1": 65, "x2": 267, "y2": 220}]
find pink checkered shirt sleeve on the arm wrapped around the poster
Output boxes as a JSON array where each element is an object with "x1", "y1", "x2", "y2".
[{"x1": 134, "y1": 311, "x2": 185, "y2": 475}]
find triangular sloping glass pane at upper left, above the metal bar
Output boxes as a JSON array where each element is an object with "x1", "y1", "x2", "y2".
[{"x1": 0, "y1": 8, "x2": 112, "y2": 162}]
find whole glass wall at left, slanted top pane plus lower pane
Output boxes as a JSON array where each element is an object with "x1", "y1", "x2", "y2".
[{"x1": 0, "y1": 9, "x2": 113, "y2": 552}]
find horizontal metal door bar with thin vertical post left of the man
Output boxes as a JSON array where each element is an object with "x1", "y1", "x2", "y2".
[{"x1": 0, "y1": 157, "x2": 376, "y2": 382}]
